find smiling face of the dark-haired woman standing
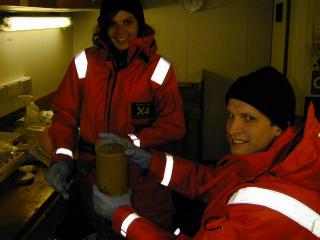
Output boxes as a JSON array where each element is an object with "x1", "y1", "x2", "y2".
[{"x1": 107, "y1": 10, "x2": 139, "y2": 51}]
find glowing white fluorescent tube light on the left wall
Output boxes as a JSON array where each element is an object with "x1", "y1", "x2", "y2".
[{"x1": 0, "y1": 17, "x2": 71, "y2": 31}]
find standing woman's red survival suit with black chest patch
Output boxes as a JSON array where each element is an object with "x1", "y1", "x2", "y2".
[{"x1": 49, "y1": 28, "x2": 185, "y2": 229}]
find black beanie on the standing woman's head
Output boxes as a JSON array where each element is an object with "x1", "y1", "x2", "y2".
[{"x1": 98, "y1": 0, "x2": 145, "y2": 28}]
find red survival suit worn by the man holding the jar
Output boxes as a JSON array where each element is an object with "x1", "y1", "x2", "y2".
[{"x1": 113, "y1": 104, "x2": 320, "y2": 240}]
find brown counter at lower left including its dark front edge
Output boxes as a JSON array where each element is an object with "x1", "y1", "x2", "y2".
[{"x1": 0, "y1": 165, "x2": 63, "y2": 240}]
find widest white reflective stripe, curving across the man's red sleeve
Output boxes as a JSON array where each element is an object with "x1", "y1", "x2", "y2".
[{"x1": 228, "y1": 187, "x2": 320, "y2": 237}]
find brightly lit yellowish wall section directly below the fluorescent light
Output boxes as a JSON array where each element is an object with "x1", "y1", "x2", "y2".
[{"x1": 0, "y1": 25, "x2": 72, "y2": 117}]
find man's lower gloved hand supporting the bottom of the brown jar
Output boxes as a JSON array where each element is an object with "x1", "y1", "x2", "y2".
[{"x1": 92, "y1": 184, "x2": 131, "y2": 220}]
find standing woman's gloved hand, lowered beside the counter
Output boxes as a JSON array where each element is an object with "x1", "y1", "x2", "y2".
[{"x1": 45, "y1": 160, "x2": 73, "y2": 193}]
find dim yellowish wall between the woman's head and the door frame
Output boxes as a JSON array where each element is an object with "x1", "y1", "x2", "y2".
[{"x1": 145, "y1": 0, "x2": 272, "y2": 82}]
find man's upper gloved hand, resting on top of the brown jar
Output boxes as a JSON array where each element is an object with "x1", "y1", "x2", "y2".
[{"x1": 100, "y1": 133, "x2": 151, "y2": 170}]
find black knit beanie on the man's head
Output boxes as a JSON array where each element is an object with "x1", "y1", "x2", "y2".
[{"x1": 225, "y1": 66, "x2": 296, "y2": 130}]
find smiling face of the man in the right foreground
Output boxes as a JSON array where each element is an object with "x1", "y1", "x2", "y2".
[{"x1": 226, "y1": 98, "x2": 281, "y2": 154}]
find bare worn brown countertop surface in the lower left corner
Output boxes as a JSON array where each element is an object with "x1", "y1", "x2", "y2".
[{"x1": 0, "y1": 163, "x2": 55, "y2": 239}]
